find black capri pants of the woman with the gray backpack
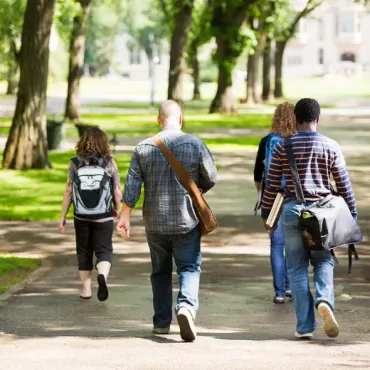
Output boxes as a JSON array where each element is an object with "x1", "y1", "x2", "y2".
[{"x1": 74, "y1": 218, "x2": 113, "y2": 271}]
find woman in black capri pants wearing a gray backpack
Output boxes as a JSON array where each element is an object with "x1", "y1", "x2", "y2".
[{"x1": 59, "y1": 127, "x2": 122, "y2": 301}]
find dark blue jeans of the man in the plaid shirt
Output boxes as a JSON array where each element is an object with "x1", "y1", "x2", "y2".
[{"x1": 147, "y1": 226, "x2": 202, "y2": 328}]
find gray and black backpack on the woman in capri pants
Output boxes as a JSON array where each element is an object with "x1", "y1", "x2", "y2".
[{"x1": 72, "y1": 156, "x2": 113, "y2": 220}]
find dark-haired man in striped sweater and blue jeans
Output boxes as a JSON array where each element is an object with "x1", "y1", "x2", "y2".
[{"x1": 262, "y1": 99, "x2": 357, "y2": 338}]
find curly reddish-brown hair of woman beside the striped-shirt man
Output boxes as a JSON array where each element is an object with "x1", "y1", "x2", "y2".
[{"x1": 271, "y1": 102, "x2": 297, "y2": 137}]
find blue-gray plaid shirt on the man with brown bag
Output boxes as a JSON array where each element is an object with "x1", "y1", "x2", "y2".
[{"x1": 122, "y1": 126, "x2": 217, "y2": 235}]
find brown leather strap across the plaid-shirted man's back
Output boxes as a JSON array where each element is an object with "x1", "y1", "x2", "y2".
[{"x1": 152, "y1": 135, "x2": 201, "y2": 197}]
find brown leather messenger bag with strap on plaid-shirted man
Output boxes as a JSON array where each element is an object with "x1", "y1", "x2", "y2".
[{"x1": 152, "y1": 136, "x2": 218, "y2": 235}]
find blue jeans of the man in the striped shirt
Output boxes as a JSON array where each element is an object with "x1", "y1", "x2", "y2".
[{"x1": 283, "y1": 201, "x2": 334, "y2": 334}]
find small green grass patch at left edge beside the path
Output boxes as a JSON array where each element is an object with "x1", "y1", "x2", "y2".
[{"x1": 0, "y1": 256, "x2": 40, "y2": 293}]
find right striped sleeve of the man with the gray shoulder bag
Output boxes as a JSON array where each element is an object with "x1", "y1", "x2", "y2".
[{"x1": 331, "y1": 145, "x2": 357, "y2": 219}]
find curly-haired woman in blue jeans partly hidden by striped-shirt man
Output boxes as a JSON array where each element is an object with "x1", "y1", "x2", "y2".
[{"x1": 254, "y1": 103, "x2": 297, "y2": 304}]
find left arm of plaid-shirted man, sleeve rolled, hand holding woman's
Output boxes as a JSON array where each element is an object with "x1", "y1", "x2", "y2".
[{"x1": 117, "y1": 148, "x2": 144, "y2": 238}]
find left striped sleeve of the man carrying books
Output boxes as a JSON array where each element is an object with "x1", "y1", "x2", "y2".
[{"x1": 261, "y1": 142, "x2": 283, "y2": 219}]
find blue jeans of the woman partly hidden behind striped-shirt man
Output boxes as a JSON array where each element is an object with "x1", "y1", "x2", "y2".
[{"x1": 270, "y1": 219, "x2": 290, "y2": 297}]
